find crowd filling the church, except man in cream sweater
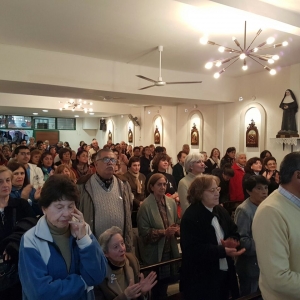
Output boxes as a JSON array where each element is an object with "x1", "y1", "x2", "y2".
[{"x1": 0, "y1": 138, "x2": 300, "y2": 300}]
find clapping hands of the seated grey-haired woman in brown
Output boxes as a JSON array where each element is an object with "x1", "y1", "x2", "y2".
[{"x1": 124, "y1": 271, "x2": 157, "y2": 299}]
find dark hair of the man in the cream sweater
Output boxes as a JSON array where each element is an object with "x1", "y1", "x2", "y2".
[{"x1": 279, "y1": 151, "x2": 300, "y2": 184}]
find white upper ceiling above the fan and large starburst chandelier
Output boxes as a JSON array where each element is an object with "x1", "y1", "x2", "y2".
[{"x1": 0, "y1": 0, "x2": 300, "y2": 117}]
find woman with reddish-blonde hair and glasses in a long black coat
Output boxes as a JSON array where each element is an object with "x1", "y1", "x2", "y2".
[{"x1": 180, "y1": 175, "x2": 245, "y2": 300}]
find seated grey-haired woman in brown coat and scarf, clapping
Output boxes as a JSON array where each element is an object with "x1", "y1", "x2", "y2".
[{"x1": 96, "y1": 226, "x2": 157, "y2": 300}]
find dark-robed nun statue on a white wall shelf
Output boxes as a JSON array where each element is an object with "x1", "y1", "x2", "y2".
[{"x1": 276, "y1": 89, "x2": 299, "y2": 138}]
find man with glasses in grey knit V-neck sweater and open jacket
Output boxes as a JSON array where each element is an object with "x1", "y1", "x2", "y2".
[{"x1": 78, "y1": 148, "x2": 133, "y2": 251}]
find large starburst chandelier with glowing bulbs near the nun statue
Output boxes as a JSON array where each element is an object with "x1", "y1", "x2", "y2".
[{"x1": 200, "y1": 21, "x2": 288, "y2": 78}]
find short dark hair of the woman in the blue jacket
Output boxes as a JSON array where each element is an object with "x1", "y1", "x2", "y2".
[{"x1": 39, "y1": 174, "x2": 79, "y2": 208}]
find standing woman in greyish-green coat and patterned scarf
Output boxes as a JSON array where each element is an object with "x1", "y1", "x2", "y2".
[{"x1": 137, "y1": 173, "x2": 180, "y2": 299}]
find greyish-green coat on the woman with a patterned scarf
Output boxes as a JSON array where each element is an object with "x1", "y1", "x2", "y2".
[{"x1": 137, "y1": 194, "x2": 179, "y2": 265}]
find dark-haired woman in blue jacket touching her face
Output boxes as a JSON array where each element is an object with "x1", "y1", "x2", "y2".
[{"x1": 19, "y1": 175, "x2": 106, "y2": 300}]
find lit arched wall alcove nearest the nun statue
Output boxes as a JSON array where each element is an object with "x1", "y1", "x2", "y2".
[{"x1": 237, "y1": 103, "x2": 267, "y2": 158}]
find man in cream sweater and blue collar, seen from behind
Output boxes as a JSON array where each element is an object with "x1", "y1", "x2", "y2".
[{"x1": 252, "y1": 152, "x2": 300, "y2": 300}]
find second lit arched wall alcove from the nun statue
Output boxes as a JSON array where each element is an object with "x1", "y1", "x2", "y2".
[{"x1": 187, "y1": 110, "x2": 203, "y2": 153}]
